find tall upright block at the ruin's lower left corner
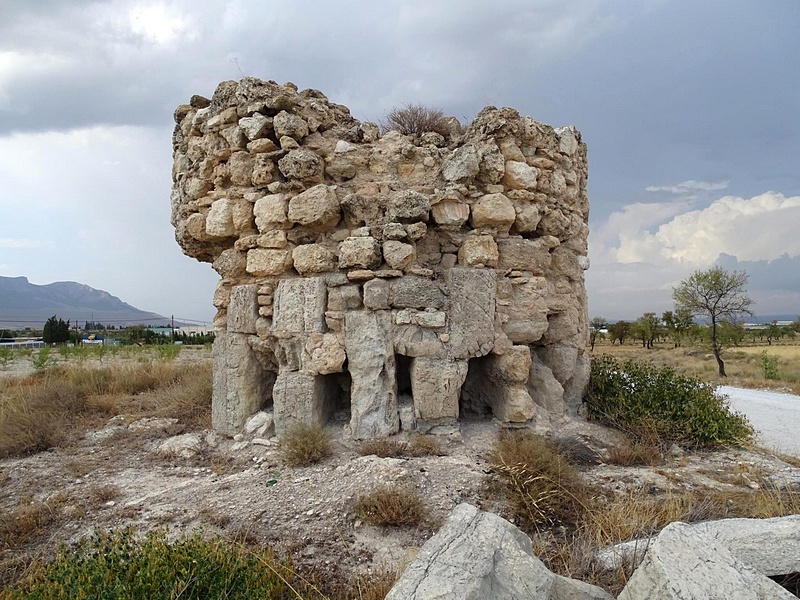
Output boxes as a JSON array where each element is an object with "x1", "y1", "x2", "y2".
[{"x1": 211, "y1": 331, "x2": 272, "y2": 435}]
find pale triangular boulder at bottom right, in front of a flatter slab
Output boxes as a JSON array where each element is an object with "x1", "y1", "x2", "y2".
[{"x1": 619, "y1": 523, "x2": 797, "y2": 600}]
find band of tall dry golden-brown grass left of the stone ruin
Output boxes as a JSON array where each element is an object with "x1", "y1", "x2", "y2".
[{"x1": 0, "y1": 362, "x2": 211, "y2": 456}]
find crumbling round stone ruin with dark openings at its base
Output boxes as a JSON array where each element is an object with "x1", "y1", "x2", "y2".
[{"x1": 171, "y1": 78, "x2": 589, "y2": 439}]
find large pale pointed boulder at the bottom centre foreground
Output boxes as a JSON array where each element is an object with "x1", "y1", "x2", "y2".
[{"x1": 386, "y1": 504, "x2": 612, "y2": 600}]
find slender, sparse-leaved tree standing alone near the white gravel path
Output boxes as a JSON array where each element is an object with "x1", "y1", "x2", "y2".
[{"x1": 672, "y1": 267, "x2": 753, "y2": 377}]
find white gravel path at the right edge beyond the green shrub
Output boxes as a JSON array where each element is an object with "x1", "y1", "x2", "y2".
[{"x1": 717, "y1": 385, "x2": 800, "y2": 458}]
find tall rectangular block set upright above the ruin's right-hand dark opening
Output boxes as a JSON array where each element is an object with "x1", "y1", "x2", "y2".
[{"x1": 445, "y1": 267, "x2": 497, "y2": 359}]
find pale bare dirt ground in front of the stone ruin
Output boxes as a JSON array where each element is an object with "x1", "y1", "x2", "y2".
[{"x1": 0, "y1": 353, "x2": 800, "y2": 592}]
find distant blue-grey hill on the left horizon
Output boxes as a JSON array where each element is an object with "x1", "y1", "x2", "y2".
[{"x1": 0, "y1": 277, "x2": 169, "y2": 329}]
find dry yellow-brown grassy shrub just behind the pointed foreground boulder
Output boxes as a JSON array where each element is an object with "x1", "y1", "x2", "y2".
[{"x1": 489, "y1": 430, "x2": 587, "y2": 531}]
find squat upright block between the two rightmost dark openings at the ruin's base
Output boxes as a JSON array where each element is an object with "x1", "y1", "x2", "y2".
[{"x1": 409, "y1": 357, "x2": 467, "y2": 424}]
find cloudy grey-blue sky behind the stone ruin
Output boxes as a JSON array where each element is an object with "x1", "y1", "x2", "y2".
[{"x1": 0, "y1": 0, "x2": 800, "y2": 321}]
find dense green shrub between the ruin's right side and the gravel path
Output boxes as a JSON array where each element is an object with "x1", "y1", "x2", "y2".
[{"x1": 584, "y1": 356, "x2": 753, "y2": 447}]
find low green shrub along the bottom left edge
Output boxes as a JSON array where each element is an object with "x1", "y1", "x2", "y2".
[{"x1": 0, "y1": 529, "x2": 323, "y2": 600}]
